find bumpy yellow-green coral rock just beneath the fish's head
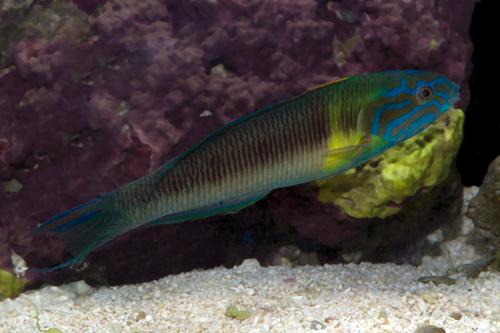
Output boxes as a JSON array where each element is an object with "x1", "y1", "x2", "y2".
[{"x1": 316, "y1": 109, "x2": 464, "y2": 218}]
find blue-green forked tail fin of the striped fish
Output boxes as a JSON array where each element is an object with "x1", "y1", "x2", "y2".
[{"x1": 34, "y1": 194, "x2": 123, "y2": 272}]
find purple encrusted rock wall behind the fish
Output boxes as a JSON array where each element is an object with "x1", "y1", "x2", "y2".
[{"x1": 0, "y1": 0, "x2": 474, "y2": 282}]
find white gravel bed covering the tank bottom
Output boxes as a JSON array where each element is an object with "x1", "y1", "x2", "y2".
[{"x1": 0, "y1": 187, "x2": 500, "y2": 333}]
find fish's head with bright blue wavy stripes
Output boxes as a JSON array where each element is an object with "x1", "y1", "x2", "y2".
[{"x1": 370, "y1": 70, "x2": 460, "y2": 142}]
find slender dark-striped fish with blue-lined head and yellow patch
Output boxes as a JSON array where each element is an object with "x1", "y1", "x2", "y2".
[{"x1": 34, "y1": 70, "x2": 460, "y2": 271}]
